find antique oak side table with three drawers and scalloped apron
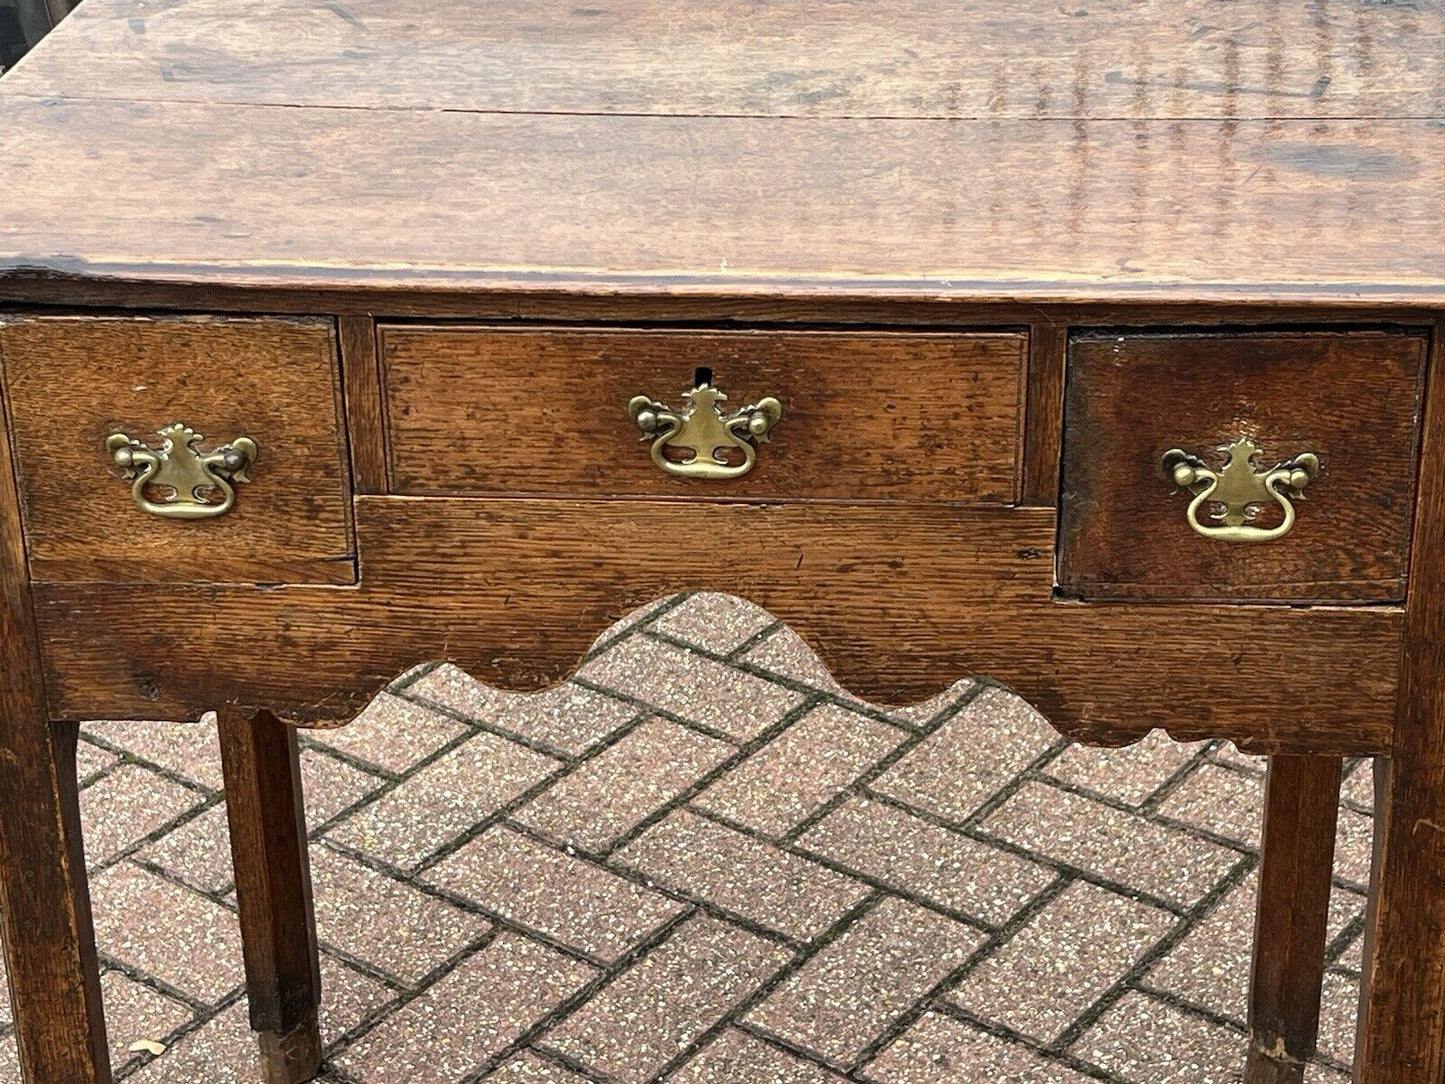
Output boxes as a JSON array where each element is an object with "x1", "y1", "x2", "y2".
[{"x1": 0, "y1": 0, "x2": 1445, "y2": 1084}]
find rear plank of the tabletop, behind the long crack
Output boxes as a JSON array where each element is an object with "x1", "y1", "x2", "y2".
[{"x1": 14, "y1": 0, "x2": 1445, "y2": 120}]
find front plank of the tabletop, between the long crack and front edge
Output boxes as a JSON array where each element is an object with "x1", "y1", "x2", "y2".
[{"x1": 0, "y1": 93, "x2": 1445, "y2": 305}]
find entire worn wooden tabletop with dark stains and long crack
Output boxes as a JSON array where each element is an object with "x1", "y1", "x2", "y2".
[{"x1": 0, "y1": 0, "x2": 1445, "y2": 305}]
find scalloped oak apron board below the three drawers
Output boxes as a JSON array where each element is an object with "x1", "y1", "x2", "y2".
[{"x1": 25, "y1": 497, "x2": 1402, "y2": 753}]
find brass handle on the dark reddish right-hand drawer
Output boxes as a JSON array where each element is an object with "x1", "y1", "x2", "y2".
[{"x1": 1162, "y1": 436, "x2": 1319, "y2": 542}]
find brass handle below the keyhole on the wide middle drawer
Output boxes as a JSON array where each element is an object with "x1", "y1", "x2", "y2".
[{"x1": 627, "y1": 369, "x2": 783, "y2": 478}]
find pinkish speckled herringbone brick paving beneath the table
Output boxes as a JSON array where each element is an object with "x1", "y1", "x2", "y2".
[{"x1": 0, "y1": 595, "x2": 1371, "y2": 1084}]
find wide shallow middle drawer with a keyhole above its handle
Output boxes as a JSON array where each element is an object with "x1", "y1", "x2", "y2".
[{"x1": 380, "y1": 325, "x2": 1027, "y2": 502}]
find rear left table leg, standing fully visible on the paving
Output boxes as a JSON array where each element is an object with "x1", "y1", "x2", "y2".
[{"x1": 220, "y1": 710, "x2": 321, "y2": 1084}]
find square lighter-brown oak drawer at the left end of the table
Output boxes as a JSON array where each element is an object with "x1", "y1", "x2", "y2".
[{"x1": 0, "y1": 315, "x2": 355, "y2": 584}]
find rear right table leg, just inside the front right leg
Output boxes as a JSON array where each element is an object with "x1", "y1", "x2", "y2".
[{"x1": 1244, "y1": 756, "x2": 1344, "y2": 1084}]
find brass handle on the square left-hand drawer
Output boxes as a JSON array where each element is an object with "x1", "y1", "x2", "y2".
[{"x1": 105, "y1": 422, "x2": 257, "y2": 519}]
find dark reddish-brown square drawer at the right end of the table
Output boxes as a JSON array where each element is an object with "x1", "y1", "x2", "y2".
[{"x1": 1058, "y1": 331, "x2": 1428, "y2": 601}]
